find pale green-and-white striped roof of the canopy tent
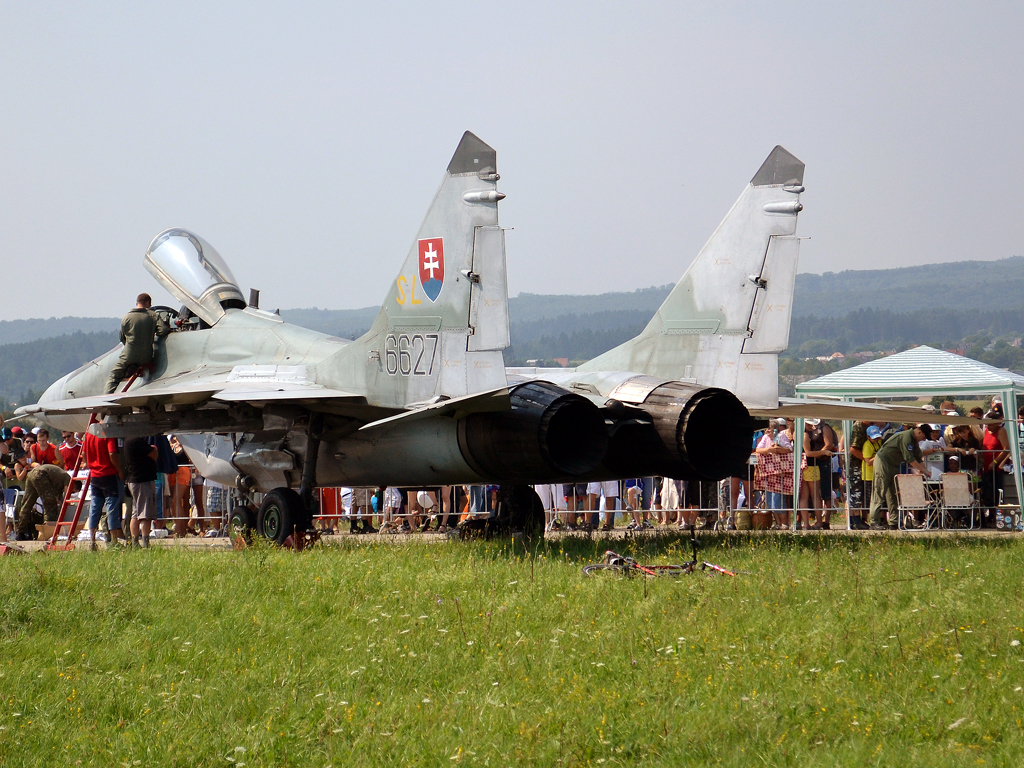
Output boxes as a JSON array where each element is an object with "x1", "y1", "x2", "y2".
[{"x1": 797, "y1": 346, "x2": 1024, "y2": 398}]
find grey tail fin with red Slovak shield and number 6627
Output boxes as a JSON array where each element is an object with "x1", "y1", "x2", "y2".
[{"x1": 353, "y1": 131, "x2": 509, "y2": 407}]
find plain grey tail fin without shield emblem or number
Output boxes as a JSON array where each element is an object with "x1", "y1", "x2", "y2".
[{"x1": 583, "y1": 146, "x2": 804, "y2": 408}]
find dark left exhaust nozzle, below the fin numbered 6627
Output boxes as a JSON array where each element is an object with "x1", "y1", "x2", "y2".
[{"x1": 459, "y1": 381, "x2": 608, "y2": 483}]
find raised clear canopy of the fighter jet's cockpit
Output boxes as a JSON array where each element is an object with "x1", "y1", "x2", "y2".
[{"x1": 143, "y1": 229, "x2": 246, "y2": 326}]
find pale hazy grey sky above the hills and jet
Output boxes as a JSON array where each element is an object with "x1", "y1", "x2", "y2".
[{"x1": 0, "y1": 0, "x2": 1024, "y2": 319}]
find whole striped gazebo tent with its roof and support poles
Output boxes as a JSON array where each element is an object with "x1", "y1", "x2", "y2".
[{"x1": 794, "y1": 346, "x2": 1024, "y2": 524}]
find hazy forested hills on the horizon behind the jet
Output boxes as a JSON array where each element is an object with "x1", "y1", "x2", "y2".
[{"x1": 6, "y1": 256, "x2": 1024, "y2": 399}]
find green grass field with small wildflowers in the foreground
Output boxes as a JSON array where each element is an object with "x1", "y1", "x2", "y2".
[{"x1": 0, "y1": 536, "x2": 1024, "y2": 767}]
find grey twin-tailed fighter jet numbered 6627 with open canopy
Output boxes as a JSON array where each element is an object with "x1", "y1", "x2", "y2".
[{"x1": 20, "y1": 131, "x2": 804, "y2": 542}]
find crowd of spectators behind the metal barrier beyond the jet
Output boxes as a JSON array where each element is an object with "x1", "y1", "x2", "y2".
[{"x1": 0, "y1": 399, "x2": 1024, "y2": 547}]
